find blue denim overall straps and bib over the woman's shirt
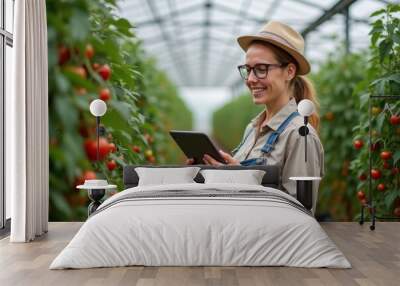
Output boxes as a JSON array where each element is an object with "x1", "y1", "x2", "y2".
[{"x1": 232, "y1": 111, "x2": 300, "y2": 166}]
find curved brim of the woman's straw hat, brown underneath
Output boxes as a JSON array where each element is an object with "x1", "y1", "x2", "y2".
[{"x1": 237, "y1": 35, "x2": 311, "y2": 75}]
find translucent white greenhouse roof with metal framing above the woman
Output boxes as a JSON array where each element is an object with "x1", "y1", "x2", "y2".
[{"x1": 119, "y1": 0, "x2": 399, "y2": 88}]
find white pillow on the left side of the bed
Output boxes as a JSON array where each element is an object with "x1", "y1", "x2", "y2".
[{"x1": 135, "y1": 167, "x2": 200, "y2": 186}]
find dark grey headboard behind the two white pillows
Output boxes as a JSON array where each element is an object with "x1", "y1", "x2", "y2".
[{"x1": 123, "y1": 165, "x2": 281, "y2": 189}]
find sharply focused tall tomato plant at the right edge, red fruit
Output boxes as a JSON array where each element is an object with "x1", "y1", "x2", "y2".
[{"x1": 351, "y1": 4, "x2": 400, "y2": 220}]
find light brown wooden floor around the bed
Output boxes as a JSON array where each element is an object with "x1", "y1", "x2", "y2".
[{"x1": 0, "y1": 222, "x2": 400, "y2": 286}]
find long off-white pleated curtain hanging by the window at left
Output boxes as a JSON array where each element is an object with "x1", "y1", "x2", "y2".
[{"x1": 6, "y1": 0, "x2": 49, "y2": 242}]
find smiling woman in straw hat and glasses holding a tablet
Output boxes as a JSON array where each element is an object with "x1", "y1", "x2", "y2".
[{"x1": 188, "y1": 21, "x2": 324, "y2": 203}]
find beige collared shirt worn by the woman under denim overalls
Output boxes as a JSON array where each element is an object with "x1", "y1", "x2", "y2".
[{"x1": 233, "y1": 98, "x2": 325, "y2": 210}]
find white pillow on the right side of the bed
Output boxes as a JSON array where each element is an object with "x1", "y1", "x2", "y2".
[{"x1": 200, "y1": 169, "x2": 265, "y2": 185}]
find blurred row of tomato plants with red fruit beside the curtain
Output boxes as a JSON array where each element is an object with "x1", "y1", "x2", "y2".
[{"x1": 46, "y1": 0, "x2": 192, "y2": 221}]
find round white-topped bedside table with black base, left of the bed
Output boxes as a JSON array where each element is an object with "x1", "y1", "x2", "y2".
[{"x1": 76, "y1": 180, "x2": 117, "y2": 216}]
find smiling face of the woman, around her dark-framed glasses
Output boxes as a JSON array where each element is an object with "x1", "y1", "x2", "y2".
[{"x1": 246, "y1": 43, "x2": 296, "y2": 104}]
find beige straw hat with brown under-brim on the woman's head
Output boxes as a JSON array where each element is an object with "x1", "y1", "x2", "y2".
[{"x1": 237, "y1": 21, "x2": 310, "y2": 75}]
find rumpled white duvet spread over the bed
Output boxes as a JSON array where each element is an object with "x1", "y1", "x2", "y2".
[{"x1": 50, "y1": 183, "x2": 351, "y2": 269}]
